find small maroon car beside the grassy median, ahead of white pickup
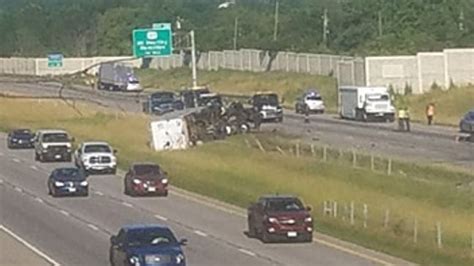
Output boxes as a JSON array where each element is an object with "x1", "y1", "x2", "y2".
[{"x1": 124, "y1": 163, "x2": 168, "y2": 196}]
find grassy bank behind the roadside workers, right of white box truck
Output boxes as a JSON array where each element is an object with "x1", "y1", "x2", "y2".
[{"x1": 398, "y1": 86, "x2": 474, "y2": 126}]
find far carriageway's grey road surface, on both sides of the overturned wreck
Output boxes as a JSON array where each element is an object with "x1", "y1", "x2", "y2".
[{"x1": 0, "y1": 81, "x2": 474, "y2": 169}]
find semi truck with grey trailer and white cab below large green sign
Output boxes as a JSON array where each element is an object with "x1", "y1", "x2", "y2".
[{"x1": 97, "y1": 63, "x2": 142, "y2": 91}]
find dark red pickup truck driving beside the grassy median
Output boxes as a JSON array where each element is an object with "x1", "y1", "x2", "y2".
[{"x1": 247, "y1": 195, "x2": 313, "y2": 243}]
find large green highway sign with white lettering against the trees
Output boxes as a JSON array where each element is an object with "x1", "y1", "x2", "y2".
[{"x1": 133, "y1": 23, "x2": 173, "y2": 57}]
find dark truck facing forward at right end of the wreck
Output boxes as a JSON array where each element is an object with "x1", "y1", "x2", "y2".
[{"x1": 250, "y1": 92, "x2": 283, "y2": 122}]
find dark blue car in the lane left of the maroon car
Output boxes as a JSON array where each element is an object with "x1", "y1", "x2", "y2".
[{"x1": 48, "y1": 167, "x2": 89, "y2": 197}]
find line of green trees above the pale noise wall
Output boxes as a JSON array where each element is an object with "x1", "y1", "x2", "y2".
[{"x1": 0, "y1": 0, "x2": 474, "y2": 57}]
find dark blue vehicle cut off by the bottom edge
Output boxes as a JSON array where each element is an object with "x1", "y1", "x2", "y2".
[{"x1": 109, "y1": 225, "x2": 187, "y2": 266}]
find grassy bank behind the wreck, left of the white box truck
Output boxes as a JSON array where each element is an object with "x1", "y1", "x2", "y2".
[{"x1": 137, "y1": 68, "x2": 337, "y2": 112}]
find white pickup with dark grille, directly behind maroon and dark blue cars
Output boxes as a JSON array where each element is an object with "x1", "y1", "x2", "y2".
[{"x1": 74, "y1": 141, "x2": 117, "y2": 174}]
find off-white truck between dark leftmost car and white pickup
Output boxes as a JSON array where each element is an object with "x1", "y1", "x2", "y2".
[{"x1": 34, "y1": 129, "x2": 74, "y2": 162}]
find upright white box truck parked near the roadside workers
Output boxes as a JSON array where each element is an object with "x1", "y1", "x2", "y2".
[{"x1": 339, "y1": 86, "x2": 395, "y2": 122}]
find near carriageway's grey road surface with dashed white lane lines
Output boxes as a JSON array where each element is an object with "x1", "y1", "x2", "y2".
[{"x1": 0, "y1": 133, "x2": 408, "y2": 266}]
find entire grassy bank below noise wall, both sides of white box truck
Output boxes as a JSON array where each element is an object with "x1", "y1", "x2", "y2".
[{"x1": 137, "y1": 68, "x2": 474, "y2": 126}]
